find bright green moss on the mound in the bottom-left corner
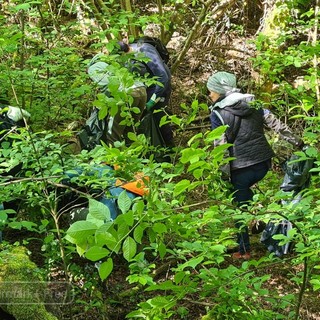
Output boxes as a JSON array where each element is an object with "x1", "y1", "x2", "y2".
[{"x1": 0, "y1": 247, "x2": 57, "y2": 320}]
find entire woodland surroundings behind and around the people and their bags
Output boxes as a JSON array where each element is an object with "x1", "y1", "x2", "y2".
[{"x1": 0, "y1": 0, "x2": 320, "y2": 320}]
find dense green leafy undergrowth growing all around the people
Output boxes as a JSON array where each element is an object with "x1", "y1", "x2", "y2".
[{"x1": 0, "y1": 1, "x2": 320, "y2": 319}]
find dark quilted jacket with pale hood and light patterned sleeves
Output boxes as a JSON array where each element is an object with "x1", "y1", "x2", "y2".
[{"x1": 210, "y1": 93, "x2": 300, "y2": 170}]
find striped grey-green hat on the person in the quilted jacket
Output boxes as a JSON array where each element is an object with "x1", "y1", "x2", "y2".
[{"x1": 207, "y1": 71, "x2": 239, "y2": 94}]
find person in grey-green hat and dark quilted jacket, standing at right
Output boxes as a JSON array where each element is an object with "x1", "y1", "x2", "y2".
[{"x1": 207, "y1": 71, "x2": 303, "y2": 260}]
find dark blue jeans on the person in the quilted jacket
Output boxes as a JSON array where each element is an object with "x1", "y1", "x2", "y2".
[{"x1": 231, "y1": 160, "x2": 271, "y2": 254}]
